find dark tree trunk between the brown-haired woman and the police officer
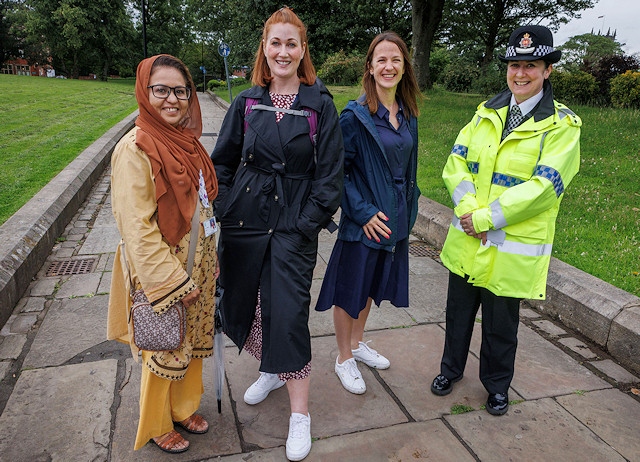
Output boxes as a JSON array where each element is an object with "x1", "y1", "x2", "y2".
[{"x1": 411, "y1": 0, "x2": 445, "y2": 90}]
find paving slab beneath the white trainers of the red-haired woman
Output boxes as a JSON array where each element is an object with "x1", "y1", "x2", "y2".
[{"x1": 226, "y1": 337, "x2": 408, "y2": 448}]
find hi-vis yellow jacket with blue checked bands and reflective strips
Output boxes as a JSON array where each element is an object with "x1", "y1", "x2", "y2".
[{"x1": 441, "y1": 81, "x2": 582, "y2": 299}]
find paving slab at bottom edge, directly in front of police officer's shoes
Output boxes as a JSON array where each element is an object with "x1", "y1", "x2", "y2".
[{"x1": 445, "y1": 398, "x2": 624, "y2": 462}]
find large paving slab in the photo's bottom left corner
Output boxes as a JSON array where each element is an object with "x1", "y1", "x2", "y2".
[{"x1": 0, "y1": 360, "x2": 117, "y2": 462}]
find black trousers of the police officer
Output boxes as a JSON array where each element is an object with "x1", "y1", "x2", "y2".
[{"x1": 440, "y1": 273, "x2": 521, "y2": 393}]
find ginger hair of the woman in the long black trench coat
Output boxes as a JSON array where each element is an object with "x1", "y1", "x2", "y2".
[{"x1": 251, "y1": 6, "x2": 316, "y2": 87}]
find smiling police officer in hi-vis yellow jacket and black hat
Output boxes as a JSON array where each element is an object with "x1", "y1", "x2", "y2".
[{"x1": 431, "y1": 25, "x2": 582, "y2": 415}]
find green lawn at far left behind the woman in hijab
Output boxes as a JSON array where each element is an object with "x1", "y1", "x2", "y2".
[{"x1": 0, "y1": 75, "x2": 138, "y2": 224}]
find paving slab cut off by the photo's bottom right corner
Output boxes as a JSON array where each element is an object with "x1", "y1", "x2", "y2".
[{"x1": 557, "y1": 390, "x2": 640, "y2": 461}]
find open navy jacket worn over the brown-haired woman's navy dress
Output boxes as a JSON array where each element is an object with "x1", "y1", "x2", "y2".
[{"x1": 338, "y1": 97, "x2": 420, "y2": 251}]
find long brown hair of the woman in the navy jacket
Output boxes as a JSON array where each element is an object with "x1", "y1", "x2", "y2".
[{"x1": 362, "y1": 31, "x2": 422, "y2": 117}]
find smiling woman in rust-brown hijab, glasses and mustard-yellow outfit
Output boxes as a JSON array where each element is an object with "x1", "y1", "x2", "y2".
[{"x1": 107, "y1": 55, "x2": 218, "y2": 453}]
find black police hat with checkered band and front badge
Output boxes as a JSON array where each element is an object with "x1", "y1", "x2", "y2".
[{"x1": 500, "y1": 26, "x2": 562, "y2": 63}]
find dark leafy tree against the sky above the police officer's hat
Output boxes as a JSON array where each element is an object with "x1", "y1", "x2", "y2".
[{"x1": 441, "y1": 0, "x2": 597, "y2": 68}]
